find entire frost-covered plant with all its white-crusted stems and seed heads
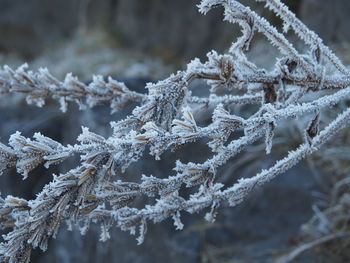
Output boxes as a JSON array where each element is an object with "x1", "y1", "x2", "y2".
[{"x1": 0, "y1": 0, "x2": 350, "y2": 263}]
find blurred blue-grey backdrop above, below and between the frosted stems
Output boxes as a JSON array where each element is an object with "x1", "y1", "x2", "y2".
[{"x1": 0, "y1": 0, "x2": 350, "y2": 263}]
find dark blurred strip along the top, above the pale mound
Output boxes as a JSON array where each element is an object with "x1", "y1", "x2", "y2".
[{"x1": 0, "y1": 0, "x2": 350, "y2": 59}]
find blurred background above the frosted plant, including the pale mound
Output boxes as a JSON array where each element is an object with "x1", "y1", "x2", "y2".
[{"x1": 0, "y1": 0, "x2": 350, "y2": 77}]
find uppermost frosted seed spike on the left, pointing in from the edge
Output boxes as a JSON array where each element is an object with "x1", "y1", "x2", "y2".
[{"x1": 0, "y1": 64, "x2": 144, "y2": 112}]
